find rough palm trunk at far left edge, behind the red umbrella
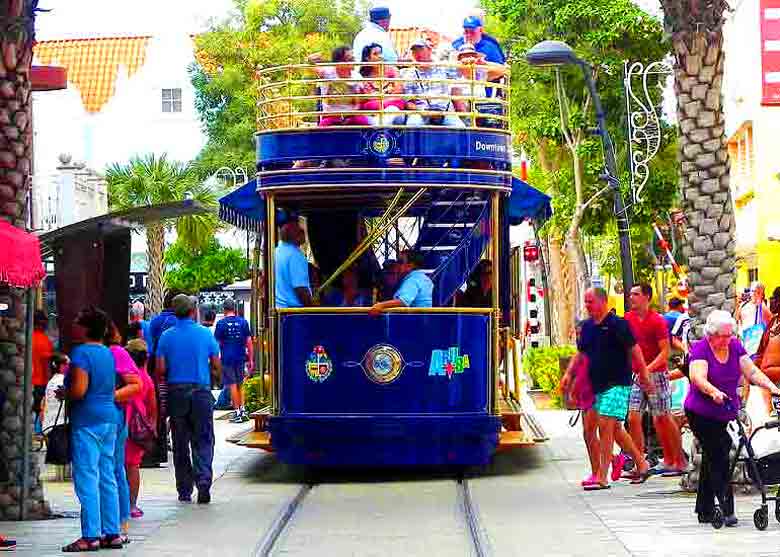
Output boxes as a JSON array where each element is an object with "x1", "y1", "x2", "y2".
[{"x1": 0, "y1": 0, "x2": 47, "y2": 520}]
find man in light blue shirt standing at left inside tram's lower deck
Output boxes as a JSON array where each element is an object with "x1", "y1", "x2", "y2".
[{"x1": 274, "y1": 221, "x2": 313, "y2": 308}]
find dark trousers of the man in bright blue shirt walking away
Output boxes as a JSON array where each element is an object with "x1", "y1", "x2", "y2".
[{"x1": 168, "y1": 383, "x2": 214, "y2": 497}]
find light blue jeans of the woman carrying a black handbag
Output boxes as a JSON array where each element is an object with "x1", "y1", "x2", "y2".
[{"x1": 71, "y1": 423, "x2": 119, "y2": 540}]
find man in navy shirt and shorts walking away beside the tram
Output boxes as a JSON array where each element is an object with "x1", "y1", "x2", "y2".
[{"x1": 214, "y1": 299, "x2": 254, "y2": 424}]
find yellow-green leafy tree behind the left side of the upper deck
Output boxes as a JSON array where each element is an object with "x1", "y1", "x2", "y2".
[{"x1": 190, "y1": 0, "x2": 360, "y2": 175}]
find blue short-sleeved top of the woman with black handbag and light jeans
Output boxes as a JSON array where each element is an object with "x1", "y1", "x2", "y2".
[{"x1": 65, "y1": 344, "x2": 119, "y2": 427}]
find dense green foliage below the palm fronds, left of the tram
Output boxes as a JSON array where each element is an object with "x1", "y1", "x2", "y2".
[{"x1": 165, "y1": 238, "x2": 249, "y2": 292}]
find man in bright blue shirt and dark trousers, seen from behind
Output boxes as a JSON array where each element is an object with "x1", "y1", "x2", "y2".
[{"x1": 156, "y1": 294, "x2": 221, "y2": 504}]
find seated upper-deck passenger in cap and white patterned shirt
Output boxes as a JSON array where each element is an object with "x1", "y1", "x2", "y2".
[{"x1": 401, "y1": 38, "x2": 466, "y2": 128}]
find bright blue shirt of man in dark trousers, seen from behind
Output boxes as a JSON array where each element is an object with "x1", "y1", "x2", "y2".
[{"x1": 157, "y1": 317, "x2": 219, "y2": 387}]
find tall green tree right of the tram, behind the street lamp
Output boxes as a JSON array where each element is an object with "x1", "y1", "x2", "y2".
[{"x1": 483, "y1": 0, "x2": 676, "y2": 341}]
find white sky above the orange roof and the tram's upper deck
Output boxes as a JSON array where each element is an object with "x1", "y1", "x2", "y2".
[{"x1": 37, "y1": 0, "x2": 478, "y2": 40}]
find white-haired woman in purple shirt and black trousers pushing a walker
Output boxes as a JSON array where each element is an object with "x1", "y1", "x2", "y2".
[{"x1": 685, "y1": 310, "x2": 780, "y2": 526}]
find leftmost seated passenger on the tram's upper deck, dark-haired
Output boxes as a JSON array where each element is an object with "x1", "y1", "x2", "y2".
[{"x1": 308, "y1": 46, "x2": 373, "y2": 126}]
